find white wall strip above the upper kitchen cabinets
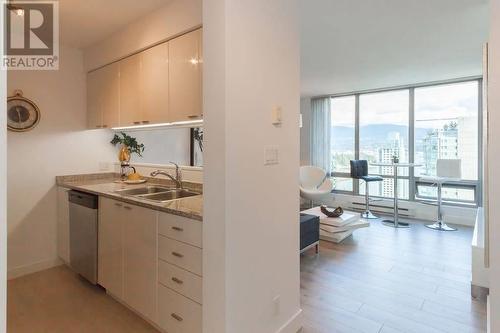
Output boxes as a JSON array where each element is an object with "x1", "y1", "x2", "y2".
[{"x1": 85, "y1": 0, "x2": 202, "y2": 70}]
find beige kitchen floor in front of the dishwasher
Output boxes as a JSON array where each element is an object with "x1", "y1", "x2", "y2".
[{"x1": 7, "y1": 266, "x2": 158, "y2": 333}]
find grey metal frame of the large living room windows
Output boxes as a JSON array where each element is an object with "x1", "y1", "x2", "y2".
[{"x1": 324, "y1": 76, "x2": 483, "y2": 207}]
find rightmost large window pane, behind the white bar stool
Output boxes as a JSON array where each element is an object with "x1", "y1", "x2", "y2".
[{"x1": 415, "y1": 81, "x2": 479, "y2": 202}]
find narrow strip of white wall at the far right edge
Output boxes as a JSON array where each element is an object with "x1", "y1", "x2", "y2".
[{"x1": 488, "y1": 0, "x2": 500, "y2": 333}]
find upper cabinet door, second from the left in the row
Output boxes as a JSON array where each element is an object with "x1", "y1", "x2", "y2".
[{"x1": 98, "y1": 63, "x2": 120, "y2": 128}]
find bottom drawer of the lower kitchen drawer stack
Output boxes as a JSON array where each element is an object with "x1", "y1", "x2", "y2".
[{"x1": 158, "y1": 285, "x2": 202, "y2": 333}]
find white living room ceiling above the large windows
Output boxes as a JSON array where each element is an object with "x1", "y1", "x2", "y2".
[{"x1": 300, "y1": 0, "x2": 489, "y2": 96}]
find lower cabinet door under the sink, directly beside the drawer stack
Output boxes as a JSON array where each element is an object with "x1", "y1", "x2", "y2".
[{"x1": 122, "y1": 204, "x2": 157, "y2": 321}]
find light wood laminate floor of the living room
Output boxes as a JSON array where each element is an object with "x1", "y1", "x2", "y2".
[{"x1": 301, "y1": 220, "x2": 486, "y2": 333}]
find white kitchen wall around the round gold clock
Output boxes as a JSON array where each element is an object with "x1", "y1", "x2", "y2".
[{"x1": 7, "y1": 47, "x2": 116, "y2": 277}]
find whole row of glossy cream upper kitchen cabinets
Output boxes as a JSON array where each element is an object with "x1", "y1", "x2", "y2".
[{"x1": 87, "y1": 29, "x2": 203, "y2": 129}]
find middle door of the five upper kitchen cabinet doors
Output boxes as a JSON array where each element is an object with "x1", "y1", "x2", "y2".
[{"x1": 118, "y1": 54, "x2": 142, "y2": 126}]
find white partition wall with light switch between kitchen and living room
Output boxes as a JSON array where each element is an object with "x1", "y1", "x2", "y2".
[{"x1": 203, "y1": 0, "x2": 301, "y2": 333}]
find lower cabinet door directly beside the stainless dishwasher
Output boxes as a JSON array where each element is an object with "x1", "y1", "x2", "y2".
[{"x1": 97, "y1": 197, "x2": 124, "y2": 299}]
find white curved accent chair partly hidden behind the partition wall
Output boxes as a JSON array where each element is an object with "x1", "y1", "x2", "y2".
[{"x1": 300, "y1": 165, "x2": 333, "y2": 207}]
